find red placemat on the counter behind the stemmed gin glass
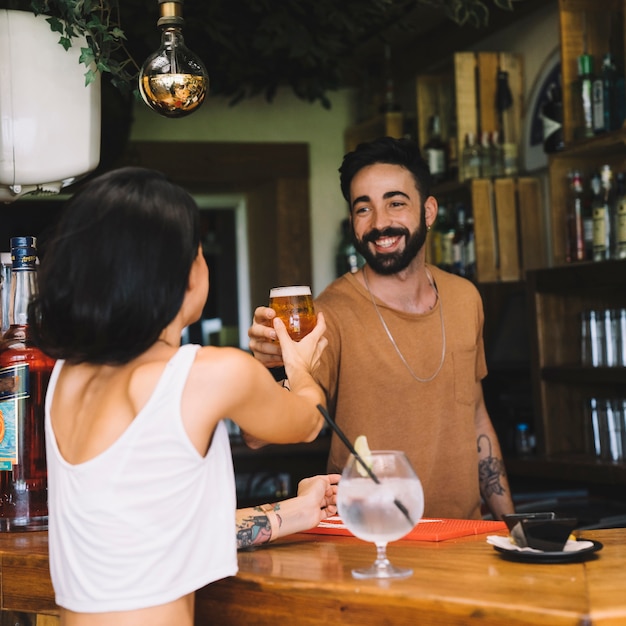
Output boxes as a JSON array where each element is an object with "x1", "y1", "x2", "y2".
[{"x1": 306, "y1": 515, "x2": 506, "y2": 541}]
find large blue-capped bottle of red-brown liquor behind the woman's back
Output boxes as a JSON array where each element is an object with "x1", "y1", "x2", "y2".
[{"x1": 0, "y1": 237, "x2": 54, "y2": 531}]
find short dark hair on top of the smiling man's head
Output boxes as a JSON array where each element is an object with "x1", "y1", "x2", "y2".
[{"x1": 339, "y1": 137, "x2": 432, "y2": 204}]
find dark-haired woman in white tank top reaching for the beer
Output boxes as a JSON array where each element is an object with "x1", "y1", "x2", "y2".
[{"x1": 30, "y1": 168, "x2": 334, "y2": 626}]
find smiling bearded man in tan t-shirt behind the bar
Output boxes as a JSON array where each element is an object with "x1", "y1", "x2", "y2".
[{"x1": 244, "y1": 137, "x2": 513, "y2": 519}]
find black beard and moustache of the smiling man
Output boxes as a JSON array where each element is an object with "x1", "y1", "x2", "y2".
[{"x1": 352, "y1": 219, "x2": 426, "y2": 276}]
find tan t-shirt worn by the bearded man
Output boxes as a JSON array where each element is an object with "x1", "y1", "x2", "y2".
[{"x1": 315, "y1": 266, "x2": 487, "y2": 519}]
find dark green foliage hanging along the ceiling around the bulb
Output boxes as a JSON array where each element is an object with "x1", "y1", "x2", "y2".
[{"x1": 0, "y1": 0, "x2": 523, "y2": 107}]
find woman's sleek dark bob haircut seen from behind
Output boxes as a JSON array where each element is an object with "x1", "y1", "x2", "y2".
[{"x1": 29, "y1": 167, "x2": 200, "y2": 365}]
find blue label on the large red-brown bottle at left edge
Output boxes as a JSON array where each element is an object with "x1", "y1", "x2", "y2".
[{"x1": 0, "y1": 365, "x2": 30, "y2": 471}]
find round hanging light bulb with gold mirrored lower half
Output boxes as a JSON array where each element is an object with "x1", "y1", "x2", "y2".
[{"x1": 139, "y1": 0, "x2": 209, "y2": 117}]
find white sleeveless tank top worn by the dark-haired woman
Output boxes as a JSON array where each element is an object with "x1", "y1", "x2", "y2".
[{"x1": 45, "y1": 344, "x2": 237, "y2": 613}]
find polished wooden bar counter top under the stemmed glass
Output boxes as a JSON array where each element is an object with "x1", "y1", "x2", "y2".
[{"x1": 0, "y1": 529, "x2": 626, "y2": 626}]
